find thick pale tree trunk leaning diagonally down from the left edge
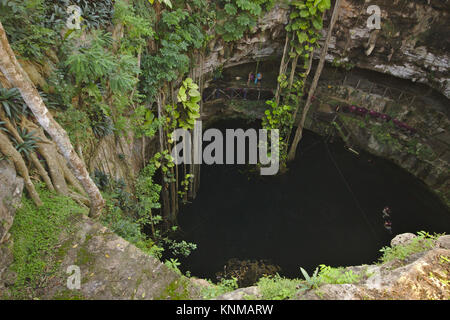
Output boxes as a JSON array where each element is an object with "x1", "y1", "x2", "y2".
[{"x1": 0, "y1": 22, "x2": 105, "y2": 217}]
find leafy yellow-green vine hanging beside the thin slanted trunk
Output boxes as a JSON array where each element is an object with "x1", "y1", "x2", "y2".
[{"x1": 263, "y1": 0, "x2": 331, "y2": 172}]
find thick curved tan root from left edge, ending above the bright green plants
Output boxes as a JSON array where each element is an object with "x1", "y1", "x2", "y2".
[{"x1": 0, "y1": 130, "x2": 42, "y2": 206}]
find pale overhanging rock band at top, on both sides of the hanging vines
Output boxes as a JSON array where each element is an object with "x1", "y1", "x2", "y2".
[{"x1": 204, "y1": 0, "x2": 450, "y2": 98}]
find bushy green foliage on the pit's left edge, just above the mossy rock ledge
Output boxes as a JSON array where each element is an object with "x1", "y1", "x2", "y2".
[{"x1": 100, "y1": 153, "x2": 197, "y2": 258}]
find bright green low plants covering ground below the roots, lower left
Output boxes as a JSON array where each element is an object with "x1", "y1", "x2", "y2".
[{"x1": 11, "y1": 185, "x2": 86, "y2": 298}]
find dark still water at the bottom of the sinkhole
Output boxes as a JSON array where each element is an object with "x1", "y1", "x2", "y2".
[{"x1": 179, "y1": 121, "x2": 450, "y2": 279}]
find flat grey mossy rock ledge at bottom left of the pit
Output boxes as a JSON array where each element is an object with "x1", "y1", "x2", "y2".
[{"x1": 38, "y1": 216, "x2": 198, "y2": 300}]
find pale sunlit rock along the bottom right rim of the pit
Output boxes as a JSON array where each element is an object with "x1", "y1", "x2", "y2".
[{"x1": 217, "y1": 233, "x2": 450, "y2": 300}]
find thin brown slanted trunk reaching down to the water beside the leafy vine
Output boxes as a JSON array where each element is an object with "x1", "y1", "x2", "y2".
[{"x1": 288, "y1": 0, "x2": 341, "y2": 161}]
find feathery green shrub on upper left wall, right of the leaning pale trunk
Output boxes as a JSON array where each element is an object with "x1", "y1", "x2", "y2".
[{"x1": 64, "y1": 31, "x2": 139, "y2": 137}]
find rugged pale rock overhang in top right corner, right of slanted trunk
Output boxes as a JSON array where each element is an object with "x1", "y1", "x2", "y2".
[{"x1": 327, "y1": 0, "x2": 450, "y2": 98}]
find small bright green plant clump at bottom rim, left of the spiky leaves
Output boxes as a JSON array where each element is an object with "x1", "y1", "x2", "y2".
[{"x1": 258, "y1": 274, "x2": 301, "y2": 300}]
